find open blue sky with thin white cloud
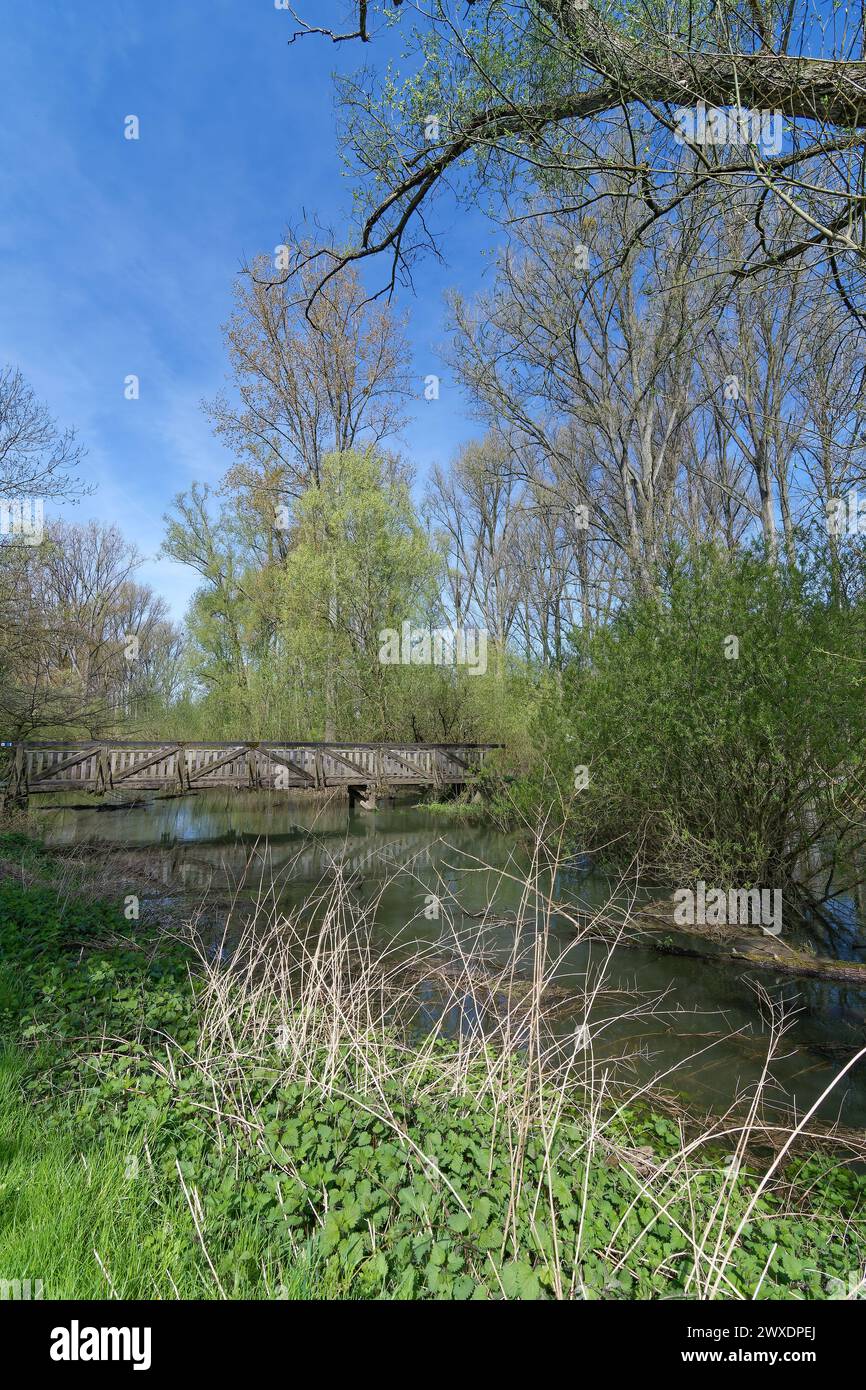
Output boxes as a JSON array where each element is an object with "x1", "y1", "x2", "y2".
[{"x1": 0, "y1": 0, "x2": 495, "y2": 617}]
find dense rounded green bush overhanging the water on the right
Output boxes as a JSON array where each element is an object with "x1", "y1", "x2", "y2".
[{"x1": 508, "y1": 548, "x2": 866, "y2": 887}]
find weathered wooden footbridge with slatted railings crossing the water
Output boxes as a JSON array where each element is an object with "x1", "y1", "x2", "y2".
[{"x1": 7, "y1": 741, "x2": 496, "y2": 809}]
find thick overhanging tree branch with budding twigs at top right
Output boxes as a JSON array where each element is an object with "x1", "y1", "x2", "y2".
[{"x1": 289, "y1": 0, "x2": 866, "y2": 322}]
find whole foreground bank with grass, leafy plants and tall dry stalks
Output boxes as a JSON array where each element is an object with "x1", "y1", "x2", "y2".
[{"x1": 0, "y1": 837, "x2": 866, "y2": 1298}]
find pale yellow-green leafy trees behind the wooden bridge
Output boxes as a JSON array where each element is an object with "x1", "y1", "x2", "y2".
[{"x1": 150, "y1": 450, "x2": 534, "y2": 742}]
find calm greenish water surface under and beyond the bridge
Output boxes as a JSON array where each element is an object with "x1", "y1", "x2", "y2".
[{"x1": 43, "y1": 791, "x2": 866, "y2": 1127}]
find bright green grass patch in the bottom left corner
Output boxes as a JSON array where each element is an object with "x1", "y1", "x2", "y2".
[{"x1": 0, "y1": 1049, "x2": 347, "y2": 1298}]
